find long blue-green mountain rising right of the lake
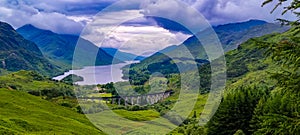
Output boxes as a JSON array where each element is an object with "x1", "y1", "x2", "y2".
[{"x1": 124, "y1": 20, "x2": 289, "y2": 84}]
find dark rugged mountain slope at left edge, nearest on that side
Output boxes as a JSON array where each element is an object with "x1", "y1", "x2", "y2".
[{"x1": 0, "y1": 22, "x2": 61, "y2": 76}]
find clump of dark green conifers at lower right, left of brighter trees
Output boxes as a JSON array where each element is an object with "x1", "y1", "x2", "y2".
[{"x1": 207, "y1": 87, "x2": 267, "y2": 135}]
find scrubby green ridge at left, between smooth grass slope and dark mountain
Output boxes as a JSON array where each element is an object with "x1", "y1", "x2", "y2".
[{"x1": 0, "y1": 70, "x2": 75, "y2": 99}]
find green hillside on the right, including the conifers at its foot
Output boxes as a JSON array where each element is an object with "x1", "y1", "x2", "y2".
[{"x1": 207, "y1": 27, "x2": 300, "y2": 135}]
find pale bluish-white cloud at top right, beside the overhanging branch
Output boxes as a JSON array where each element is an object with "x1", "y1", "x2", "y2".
[{"x1": 189, "y1": 0, "x2": 294, "y2": 25}]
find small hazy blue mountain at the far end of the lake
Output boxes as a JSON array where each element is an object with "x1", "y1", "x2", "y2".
[{"x1": 101, "y1": 48, "x2": 145, "y2": 61}]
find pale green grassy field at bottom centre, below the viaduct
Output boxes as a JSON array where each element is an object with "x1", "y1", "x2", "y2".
[{"x1": 87, "y1": 111, "x2": 176, "y2": 134}]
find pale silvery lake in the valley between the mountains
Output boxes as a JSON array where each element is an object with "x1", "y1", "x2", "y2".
[{"x1": 53, "y1": 61, "x2": 138, "y2": 85}]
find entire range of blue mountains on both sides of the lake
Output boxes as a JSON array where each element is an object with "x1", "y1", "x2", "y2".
[{"x1": 0, "y1": 20, "x2": 289, "y2": 75}]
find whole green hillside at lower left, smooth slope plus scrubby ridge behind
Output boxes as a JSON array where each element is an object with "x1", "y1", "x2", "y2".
[{"x1": 0, "y1": 70, "x2": 102, "y2": 134}]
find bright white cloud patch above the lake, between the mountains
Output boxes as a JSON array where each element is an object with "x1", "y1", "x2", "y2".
[{"x1": 85, "y1": 21, "x2": 191, "y2": 55}]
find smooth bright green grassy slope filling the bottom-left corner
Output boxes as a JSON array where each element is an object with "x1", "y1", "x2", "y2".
[{"x1": 0, "y1": 88, "x2": 103, "y2": 134}]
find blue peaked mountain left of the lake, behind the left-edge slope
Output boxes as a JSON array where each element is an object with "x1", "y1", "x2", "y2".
[{"x1": 17, "y1": 24, "x2": 122, "y2": 66}]
